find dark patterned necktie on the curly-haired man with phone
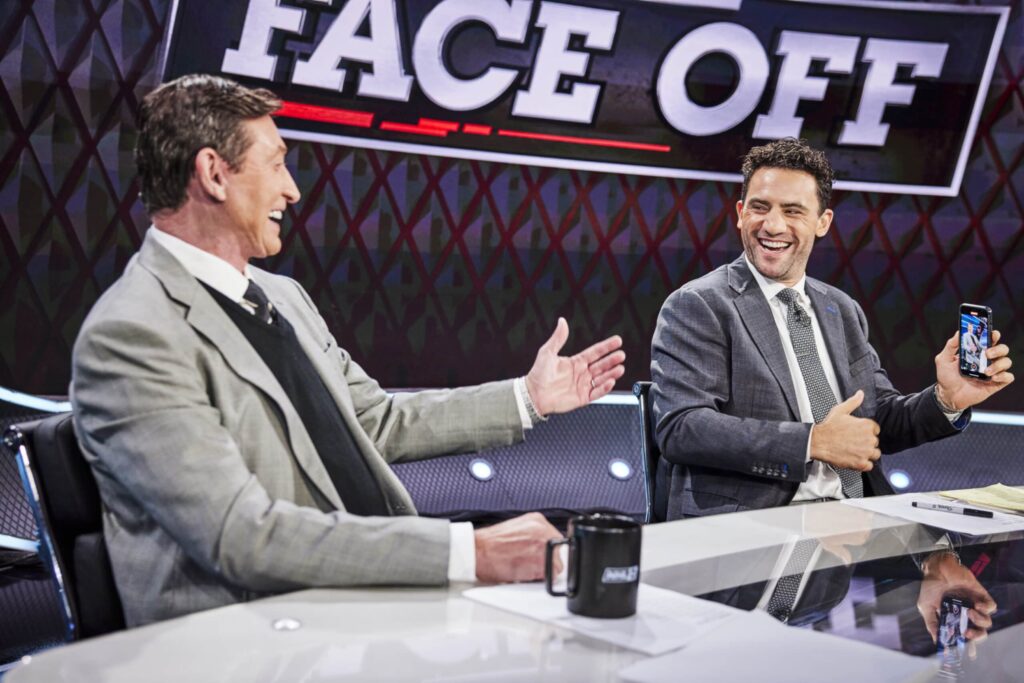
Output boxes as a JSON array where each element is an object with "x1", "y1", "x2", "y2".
[{"x1": 776, "y1": 289, "x2": 864, "y2": 498}]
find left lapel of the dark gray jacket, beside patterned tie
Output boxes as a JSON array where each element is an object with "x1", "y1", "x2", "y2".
[{"x1": 729, "y1": 256, "x2": 800, "y2": 419}]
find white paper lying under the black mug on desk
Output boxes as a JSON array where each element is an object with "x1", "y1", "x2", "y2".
[{"x1": 463, "y1": 584, "x2": 746, "y2": 654}]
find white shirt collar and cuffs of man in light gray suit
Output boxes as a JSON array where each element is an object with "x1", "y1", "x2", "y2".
[{"x1": 150, "y1": 225, "x2": 534, "y2": 582}]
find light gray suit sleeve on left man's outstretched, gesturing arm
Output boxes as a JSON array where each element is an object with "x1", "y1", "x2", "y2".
[{"x1": 288, "y1": 283, "x2": 523, "y2": 463}]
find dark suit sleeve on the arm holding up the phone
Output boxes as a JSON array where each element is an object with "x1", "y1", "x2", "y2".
[{"x1": 850, "y1": 301, "x2": 971, "y2": 453}]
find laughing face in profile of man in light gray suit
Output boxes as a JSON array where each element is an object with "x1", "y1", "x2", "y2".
[{"x1": 224, "y1": 116, "x2": 299, "y2": 261}]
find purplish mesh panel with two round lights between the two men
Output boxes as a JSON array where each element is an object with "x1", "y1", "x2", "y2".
[{"x1": 393, "y1": 393, "x2": 647, "y2": 525}]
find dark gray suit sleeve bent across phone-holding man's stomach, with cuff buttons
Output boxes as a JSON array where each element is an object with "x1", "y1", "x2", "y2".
[{"x1": 651, "y1": 290, "x2": 810, "y2": 481}]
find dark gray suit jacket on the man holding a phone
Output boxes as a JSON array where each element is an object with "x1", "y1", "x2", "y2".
[{"x1": 651, "y1": 256, "x2": 970, "y2": 519}]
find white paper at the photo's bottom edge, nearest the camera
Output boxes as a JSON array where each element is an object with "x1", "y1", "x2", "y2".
[{"x1": 618, "y1": 611, "x2": 938, "y2": 683}]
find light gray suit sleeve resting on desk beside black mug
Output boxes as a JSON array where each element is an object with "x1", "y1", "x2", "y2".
[{"x1": 72, "y1": 321, "x2": 449, "y2": 592}]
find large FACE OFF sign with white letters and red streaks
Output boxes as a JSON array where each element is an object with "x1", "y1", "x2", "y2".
[{"x1": 164, "y1": 0, "x2": 1009, "y2": 195}]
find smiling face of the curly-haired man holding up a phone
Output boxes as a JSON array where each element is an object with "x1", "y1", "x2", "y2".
[{"x1": 736, "y1": 168, "x2": 833, "y2": 287}]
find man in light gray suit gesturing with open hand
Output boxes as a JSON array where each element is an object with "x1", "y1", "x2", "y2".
[{"x1": 71, "y1": 76, "x2": 625, "y2": 626}]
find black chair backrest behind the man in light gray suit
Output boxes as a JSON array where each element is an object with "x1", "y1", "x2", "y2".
[{"x1": 4, "y1": 413, "x2": 125, "y2": 639}]
